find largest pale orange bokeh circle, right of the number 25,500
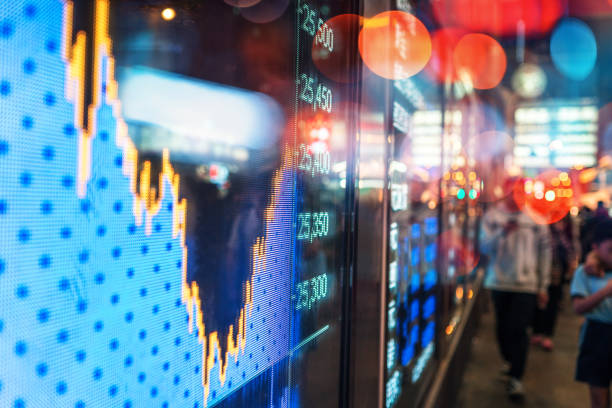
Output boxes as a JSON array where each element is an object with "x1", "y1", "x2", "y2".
[{"x1": 359, "y1": 11, "x2": 431, "y2": 79}]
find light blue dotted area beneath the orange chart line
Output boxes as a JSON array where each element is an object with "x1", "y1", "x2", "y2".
[{"x1": 0, "y1": 0, "x2": 292, "y2": 408}]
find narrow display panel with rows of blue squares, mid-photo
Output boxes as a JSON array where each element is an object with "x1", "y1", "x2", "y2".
[{"x1": 384, "y1": 29, "x2": 444, "y2": 408}]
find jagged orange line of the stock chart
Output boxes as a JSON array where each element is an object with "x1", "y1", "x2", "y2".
[{"x1": 63, "y1": 0, "x2": 290, "y2": 404}]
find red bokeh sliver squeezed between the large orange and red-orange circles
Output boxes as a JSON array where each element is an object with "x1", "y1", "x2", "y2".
[{"x1": 425, "y1": 28, "x2": 467, "y2": 83}]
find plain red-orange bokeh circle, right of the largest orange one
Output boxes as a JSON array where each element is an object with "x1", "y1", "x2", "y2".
[{"x1": 453, "y1": 34, "x2": 506, "y2": 89}]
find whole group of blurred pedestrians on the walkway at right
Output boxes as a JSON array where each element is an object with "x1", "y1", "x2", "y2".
[{"x1": 481, "y1": 191, "x2": 612, "y2": 408}]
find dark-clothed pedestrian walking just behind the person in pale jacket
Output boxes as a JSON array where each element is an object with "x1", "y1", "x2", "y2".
[{"x1": 531, "y1": 215, "x2": 577, "y2": 351}]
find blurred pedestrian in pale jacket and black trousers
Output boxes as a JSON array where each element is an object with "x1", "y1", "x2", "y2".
[{"x1": 480, "y1": 189, "x2": 552, "y2": 399}]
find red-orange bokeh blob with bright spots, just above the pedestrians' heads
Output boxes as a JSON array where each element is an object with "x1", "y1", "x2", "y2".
[{"x1": 513, "y1": 170, "x2": 577, "y2": 225}]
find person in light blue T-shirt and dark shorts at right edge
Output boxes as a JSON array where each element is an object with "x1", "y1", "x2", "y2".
[{"x1": 570, "y1": 219, "x2": 612, "y2": 408}]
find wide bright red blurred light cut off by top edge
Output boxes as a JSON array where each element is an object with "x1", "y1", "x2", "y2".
[{"x1": 433, "y1": 0, "x2": 563, "y2": 36}]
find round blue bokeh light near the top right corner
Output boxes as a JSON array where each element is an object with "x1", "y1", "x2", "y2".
[{"x1": 550, "y1": 18, "x2": 597, "y2": 81}]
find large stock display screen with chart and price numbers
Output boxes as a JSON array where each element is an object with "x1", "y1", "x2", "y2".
[{"x1": 0, "y1": 0, "x2": 354, "y2": 408}]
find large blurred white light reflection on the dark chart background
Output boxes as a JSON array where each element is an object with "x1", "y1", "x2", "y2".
[{"x1": 119, "y1": 67, "x2": 283, "y2": 152}]
